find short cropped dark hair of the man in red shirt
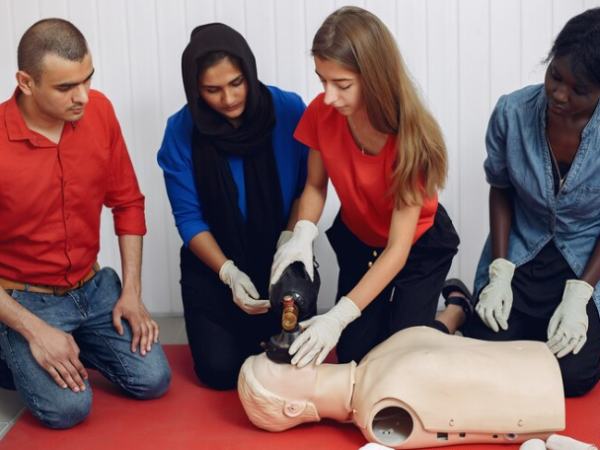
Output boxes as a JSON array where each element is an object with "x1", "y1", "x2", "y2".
[{"x1": 17, "y1": 19, "x2": 89, "y2": 82}]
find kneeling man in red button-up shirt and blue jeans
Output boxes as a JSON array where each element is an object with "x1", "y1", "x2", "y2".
[{"x1": 0, "y1": 19, "x2": 171, "y2": 428}]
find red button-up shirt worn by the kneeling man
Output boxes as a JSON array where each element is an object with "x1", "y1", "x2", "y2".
[{"x1": 0, "y1": 89, "x2": 146, "y2": 286}]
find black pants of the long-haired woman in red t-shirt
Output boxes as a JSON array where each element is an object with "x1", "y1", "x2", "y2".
[{"x1": 327, "y1": 205, "x2": 459, "y2": 363}]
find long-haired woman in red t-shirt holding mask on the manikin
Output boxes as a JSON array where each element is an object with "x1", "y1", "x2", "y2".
[{"x1": 271, "y1": 7, "x2": 472, "y2": 367}]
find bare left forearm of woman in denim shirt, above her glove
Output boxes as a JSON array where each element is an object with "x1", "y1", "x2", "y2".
[{"x1": 489, "y1": 187, "x2": 512, "y2": 259}]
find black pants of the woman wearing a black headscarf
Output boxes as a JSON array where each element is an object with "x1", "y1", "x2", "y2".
[{"x1": 181, "y1": 247, "x2": 281, "y2": 390}]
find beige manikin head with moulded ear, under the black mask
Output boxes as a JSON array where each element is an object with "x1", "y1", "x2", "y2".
[{"x1": 238, "y1": 353, "x2": 321, "y2": 431}]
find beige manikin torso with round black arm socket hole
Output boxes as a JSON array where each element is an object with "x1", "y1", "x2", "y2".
[{"x1": 352, "y1": 327, "x2": 565, "y2": 448}]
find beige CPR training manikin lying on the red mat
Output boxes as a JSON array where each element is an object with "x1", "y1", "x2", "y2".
[{"x1": 238, "y1": 327, "x2": 565, "y2": 449}]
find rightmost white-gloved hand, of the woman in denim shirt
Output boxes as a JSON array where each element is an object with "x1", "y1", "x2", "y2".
[{"x1": 547, "y1": 280, "x2": 594, "y2": 358}]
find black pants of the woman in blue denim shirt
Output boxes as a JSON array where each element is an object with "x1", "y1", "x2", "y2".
[{"x1": 465, "y1": 300, "x2": 600, "y2": 397}]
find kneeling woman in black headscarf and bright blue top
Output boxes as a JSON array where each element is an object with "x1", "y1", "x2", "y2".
[{"x1": 158, "y1": 23, "x2": 307, "y2": 389}]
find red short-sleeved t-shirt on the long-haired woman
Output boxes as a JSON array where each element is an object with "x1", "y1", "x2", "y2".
[{"x1": 294, "y1": 94, "x2": 438, "y2": 247}]
